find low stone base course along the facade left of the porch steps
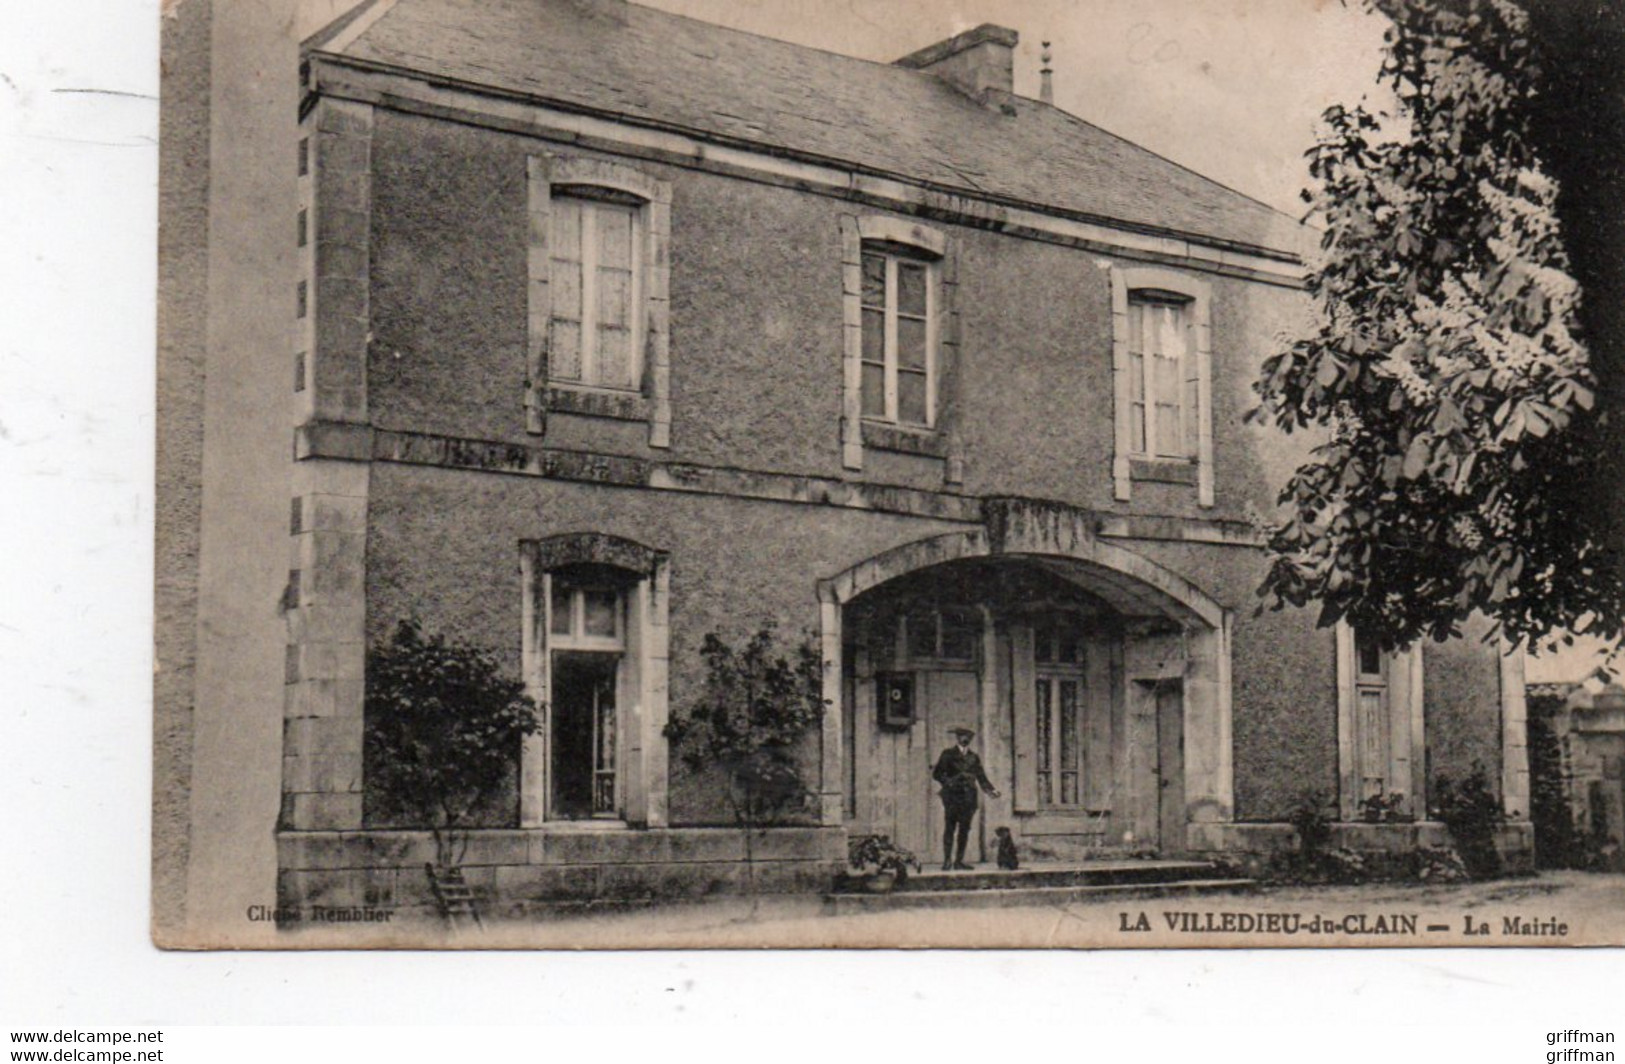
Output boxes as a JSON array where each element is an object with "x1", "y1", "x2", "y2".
[{"x1": 276, "y1": 827, "x2": 847, "y2": 918}]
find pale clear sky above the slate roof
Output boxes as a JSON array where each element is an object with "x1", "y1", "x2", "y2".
[{"x1": 301, "y1": 0, "x2": 1383, "y2": 218}]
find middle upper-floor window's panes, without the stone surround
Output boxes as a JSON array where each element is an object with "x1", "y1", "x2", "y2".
[{"x1": 861, "y1": 245, "x2": 936, "y2": 427}]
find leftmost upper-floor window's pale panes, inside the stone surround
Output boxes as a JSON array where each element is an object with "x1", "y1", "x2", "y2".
[{"x1": 548, "y1": 190, "x2": 644, "y2": 391}]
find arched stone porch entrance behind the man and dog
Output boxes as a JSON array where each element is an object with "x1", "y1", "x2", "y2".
[{"x1": 819, "y1": 502, "x2": 1232, "y2": 859}]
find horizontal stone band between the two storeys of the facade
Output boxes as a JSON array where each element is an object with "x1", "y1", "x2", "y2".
[{"x1": 294, "y1": 421, "x2": 1263, "y2": 549}]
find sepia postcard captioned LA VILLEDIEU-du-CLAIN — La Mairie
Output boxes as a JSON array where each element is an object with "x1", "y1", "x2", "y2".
[{"x1": 153, "y1": 0, "x2": 1625, "y2": 949}]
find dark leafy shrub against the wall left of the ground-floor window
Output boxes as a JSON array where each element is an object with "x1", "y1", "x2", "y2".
[{"x1": 364, "y1": 621, "x2": 540, "y2": 864}]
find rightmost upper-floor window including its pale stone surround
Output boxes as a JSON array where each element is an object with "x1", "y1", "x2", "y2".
[{"x1": 1112, "y1": 261, "x2": 1214, "y2": 507}]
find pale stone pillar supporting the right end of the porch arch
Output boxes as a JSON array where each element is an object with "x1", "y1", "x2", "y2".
[{"x1": 1185, "y1": 611, "x2": 1235, "y2": 850}]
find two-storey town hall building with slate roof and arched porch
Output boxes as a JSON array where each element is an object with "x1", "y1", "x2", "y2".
[{"x1": 256, "y1": 0, "x2": 1528, "y2": 906}]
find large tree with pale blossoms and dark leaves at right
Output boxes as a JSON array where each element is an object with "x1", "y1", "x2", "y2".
[{"x1": 1255, "y1": 0, "x2": 1625, "y2": 647}]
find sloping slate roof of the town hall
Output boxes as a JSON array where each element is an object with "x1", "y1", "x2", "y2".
[{"x1": 307, "y1": 0, "x2": 1303, "y2": 252}]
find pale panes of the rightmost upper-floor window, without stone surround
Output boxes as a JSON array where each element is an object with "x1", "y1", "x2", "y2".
[{"x1": 1128, "y1": 292, "x2": 1196, "y2": 458}]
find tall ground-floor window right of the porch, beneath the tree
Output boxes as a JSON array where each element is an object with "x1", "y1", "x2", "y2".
[{"x1": 1336, "y1": 624, "x2": 1425, "y2": 820}]
